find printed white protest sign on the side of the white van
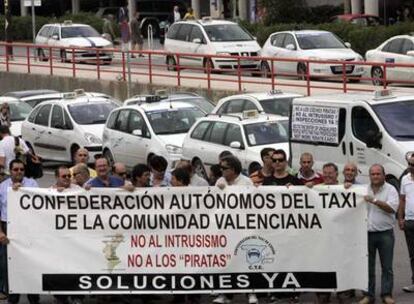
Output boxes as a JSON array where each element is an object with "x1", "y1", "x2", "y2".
[{"x1": 291, "y1": 105, "x2": 339, "y2": 144}]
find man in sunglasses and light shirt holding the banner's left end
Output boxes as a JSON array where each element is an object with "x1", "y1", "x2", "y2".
[{"x1": 0, "y1": 159, "x2": 39, "y2": 304}]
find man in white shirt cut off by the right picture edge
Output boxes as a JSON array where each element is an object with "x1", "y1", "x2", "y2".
[{"x1": 398, "y1": 154, "x2": 414, "y2": 292}]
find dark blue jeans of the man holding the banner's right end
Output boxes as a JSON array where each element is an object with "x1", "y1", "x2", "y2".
[{"x1": 367, "y1": 229, "x2": 394, "y2": 298}]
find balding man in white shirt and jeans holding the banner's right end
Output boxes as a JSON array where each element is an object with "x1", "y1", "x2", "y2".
[{"x1": 359, "y1": 164, "x2": 398, "y2": 304}]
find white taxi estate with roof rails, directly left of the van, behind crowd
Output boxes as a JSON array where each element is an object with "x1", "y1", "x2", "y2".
[{"x1": 183, "y1": 110, "x2": 289, "y2": 176}]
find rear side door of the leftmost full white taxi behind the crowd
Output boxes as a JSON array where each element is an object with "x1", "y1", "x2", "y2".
[{"x1": 29, "y1": 104, "x2": 53, "y2": 159}]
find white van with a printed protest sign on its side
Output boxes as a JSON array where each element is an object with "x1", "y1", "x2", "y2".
[{"x1": 290, "y1": 90, "x2": 414, "y2": 186}]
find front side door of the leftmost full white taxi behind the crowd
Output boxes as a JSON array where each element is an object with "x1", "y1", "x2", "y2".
[{"x1": 47, "y1": 104, "x2": 73, "y2": 161}]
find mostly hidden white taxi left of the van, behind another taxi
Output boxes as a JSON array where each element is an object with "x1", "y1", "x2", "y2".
[{"x1": 212, "y1": 90, "x2": 303, "y2": 116}]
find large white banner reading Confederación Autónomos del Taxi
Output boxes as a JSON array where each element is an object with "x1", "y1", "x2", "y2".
[{"x1": 8, "y1": 186, "x2": 368, "y2": 294}]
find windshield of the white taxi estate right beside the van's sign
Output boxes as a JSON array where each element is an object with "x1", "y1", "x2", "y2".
[{"x1": 244, "y1": 120, "x2": 289, "y2": 146}]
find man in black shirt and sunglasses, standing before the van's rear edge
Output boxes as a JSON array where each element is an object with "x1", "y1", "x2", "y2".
[{"x1": 263, "y1": 149, "x2": 302, "y2": 186}]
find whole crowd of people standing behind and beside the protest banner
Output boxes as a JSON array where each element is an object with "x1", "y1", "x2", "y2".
[{"x1": 0, "y1": 135, "x2": 414, "y2": 304}]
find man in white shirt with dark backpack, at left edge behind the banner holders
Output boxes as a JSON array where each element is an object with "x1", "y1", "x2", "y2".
[{"x1": 0, "y1": 126, "x2": 30, "y2": 174}]
